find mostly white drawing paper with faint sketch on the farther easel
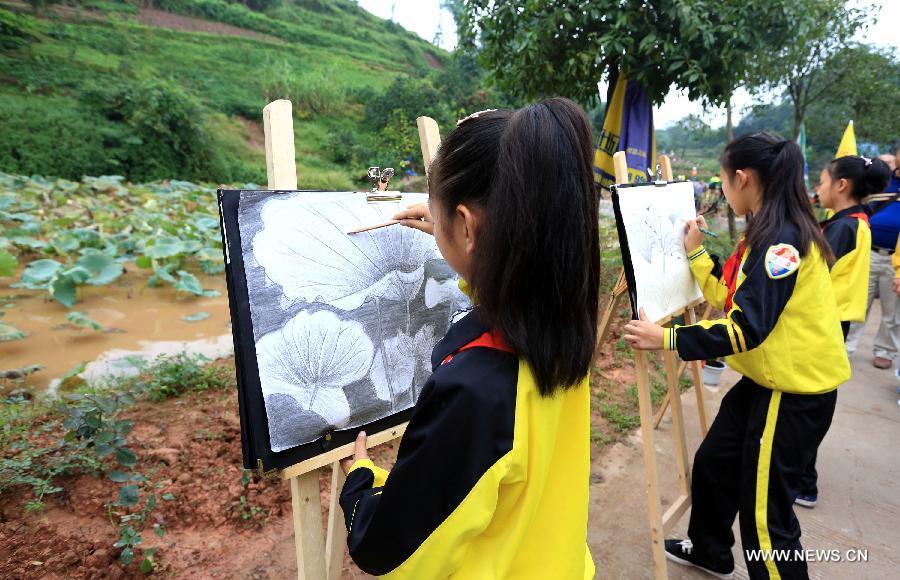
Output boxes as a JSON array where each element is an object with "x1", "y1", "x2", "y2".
[{"x1": 618, "y1": 182, "x2": 703, "y2": 321}]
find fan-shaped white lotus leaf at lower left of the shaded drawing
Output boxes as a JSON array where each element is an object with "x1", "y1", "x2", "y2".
[{"x1": 256, "y1": 311, "x2": 374, "y2": 451}]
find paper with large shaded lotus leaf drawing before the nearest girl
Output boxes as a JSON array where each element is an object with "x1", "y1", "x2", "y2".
[{"x1": 238, "y1": 191, "x2": 469, "y2": 452}]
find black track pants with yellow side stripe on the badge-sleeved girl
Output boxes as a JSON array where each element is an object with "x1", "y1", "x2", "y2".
[{"x1": 688, "y1": 377, "x2": 837, "y2": 579}]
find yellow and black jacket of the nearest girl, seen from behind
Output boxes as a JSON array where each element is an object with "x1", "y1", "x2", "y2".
[{"x1": 340, "y1": 308, "x2": 594, "y2": 580}]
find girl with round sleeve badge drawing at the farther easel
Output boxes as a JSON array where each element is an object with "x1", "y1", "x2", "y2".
[{"x1": 626, "y1": 133, "x2": 850, "y2": 578}]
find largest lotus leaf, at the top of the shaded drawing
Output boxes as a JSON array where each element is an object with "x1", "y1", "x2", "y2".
[{"x1": 253, "y1": 196, "x2": 439, "y2": 310}]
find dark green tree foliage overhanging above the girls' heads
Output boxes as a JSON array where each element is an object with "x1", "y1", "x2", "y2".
[{"x1": 460, "y1": 0, "x2": 815, "y2": 104}]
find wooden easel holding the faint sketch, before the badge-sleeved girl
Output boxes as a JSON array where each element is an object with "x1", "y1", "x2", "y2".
[{"x1": 601, "y1": 151, "x2": 706, "y2": 580}]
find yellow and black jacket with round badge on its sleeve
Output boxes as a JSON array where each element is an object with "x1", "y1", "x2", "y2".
[{"x1": 664, "y1": 222, "x2": 850, "y2": 394}]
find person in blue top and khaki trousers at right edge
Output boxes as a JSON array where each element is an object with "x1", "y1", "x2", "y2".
[{"x1": 847, "y1": 142, "x2": 900, "y2": 369}]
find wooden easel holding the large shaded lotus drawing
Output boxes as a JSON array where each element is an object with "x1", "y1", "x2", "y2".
[{"x1": 263, "y1": 99, "x2": 440, "y2": 580}]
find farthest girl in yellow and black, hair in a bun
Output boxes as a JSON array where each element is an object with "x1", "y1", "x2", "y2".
[{"x1": 795, "y1": 155, "x2": 890, "y2": 508}]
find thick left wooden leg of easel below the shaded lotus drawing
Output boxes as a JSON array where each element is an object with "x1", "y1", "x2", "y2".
[{"x1": 291, "y1": 469, "x2": 325, "y2": 580}]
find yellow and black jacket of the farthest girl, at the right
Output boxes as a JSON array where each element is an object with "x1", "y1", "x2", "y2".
[{"x1": 822, "y1": 205, "x2": 872, "y2": 322}]
